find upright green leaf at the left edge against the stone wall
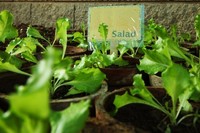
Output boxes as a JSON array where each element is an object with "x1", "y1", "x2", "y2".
[{"x1": 0, "y1": 10, "x2": 18, "y2": 43}]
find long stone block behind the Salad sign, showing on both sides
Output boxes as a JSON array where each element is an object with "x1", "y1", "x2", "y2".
[{"x1": 74, "y1": 2, "x2": 200, "y2": 35}]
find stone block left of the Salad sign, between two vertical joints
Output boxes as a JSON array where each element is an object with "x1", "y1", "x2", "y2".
[{"x1": 31, "y1": 2, "x2": 74, "y2": 28}]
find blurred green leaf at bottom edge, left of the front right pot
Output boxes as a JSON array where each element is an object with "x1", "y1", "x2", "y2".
[{"x1": 50, "y1": 100, "x2": 90, "y2": 133}]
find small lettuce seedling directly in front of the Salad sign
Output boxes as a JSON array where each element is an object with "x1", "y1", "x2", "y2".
[{"x1": 76, "y1": 23, "x2": 138, "y2": 68}]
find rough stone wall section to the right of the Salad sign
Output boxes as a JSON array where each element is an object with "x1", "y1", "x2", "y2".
[{"x1": 145, "y1": 3, "x2": 200, "y2": 35}]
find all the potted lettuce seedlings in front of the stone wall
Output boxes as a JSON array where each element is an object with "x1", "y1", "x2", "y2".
[{"x1": 0, "y1": 10, "x2": 200, "y2": 133}]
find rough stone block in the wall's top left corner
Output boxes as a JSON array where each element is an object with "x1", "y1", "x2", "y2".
[{"x1": 0, "y1": 2, "x2": 31, "y2": 25}]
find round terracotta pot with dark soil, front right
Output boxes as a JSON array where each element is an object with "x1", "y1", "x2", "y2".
[{"x1": 96, "y1": 86, "x2": 200, "y2": 133}]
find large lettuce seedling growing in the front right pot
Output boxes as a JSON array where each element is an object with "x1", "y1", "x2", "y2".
[{"x1": 114, "y1": 64, "x2": 200, "y2": 130}]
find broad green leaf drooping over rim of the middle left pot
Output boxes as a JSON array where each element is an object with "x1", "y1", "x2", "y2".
[{"x1": 67, "y1": 68, "x2": 106, "y2": 93}]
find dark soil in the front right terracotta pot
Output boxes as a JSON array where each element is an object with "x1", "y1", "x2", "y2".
[{"x1": 114, "y1": 104, "x2": 200, "y2": 133}]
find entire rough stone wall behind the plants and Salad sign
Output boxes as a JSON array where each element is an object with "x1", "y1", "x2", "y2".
[{"x1": 0, "y1": 0, "x2": 200, "y2": 33}]
